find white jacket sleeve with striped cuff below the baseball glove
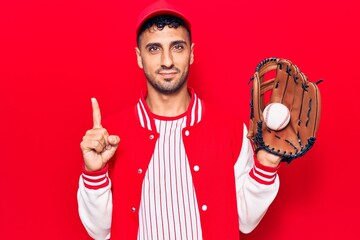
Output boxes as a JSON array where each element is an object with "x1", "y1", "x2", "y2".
[{"x1": 234, "y1": 124, "x2": 280, "y2": 233}]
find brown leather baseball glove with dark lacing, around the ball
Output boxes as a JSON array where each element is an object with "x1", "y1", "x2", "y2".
[{"x1": 247, "y1": 58, "x2": 321, "y2": 163}]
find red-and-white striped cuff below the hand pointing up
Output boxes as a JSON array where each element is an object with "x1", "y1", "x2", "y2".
[{"x1": 82, "y1": 164, "x2": 109, "y2": 190}]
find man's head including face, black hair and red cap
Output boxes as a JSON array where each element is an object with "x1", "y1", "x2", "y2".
[{"x1": 136, "y1": 1, "x2": 194, "y2": 94}]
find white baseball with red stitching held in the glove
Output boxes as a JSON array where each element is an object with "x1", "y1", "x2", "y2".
[{"x1": 263, "y1": 103, "x2": 290, "y2": 131}]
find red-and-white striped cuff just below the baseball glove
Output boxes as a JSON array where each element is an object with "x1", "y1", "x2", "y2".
[{"x1": 249, "y1": 157, "x2": 280, "y2": 185}]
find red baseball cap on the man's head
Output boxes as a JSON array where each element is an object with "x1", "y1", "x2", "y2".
[{"x1": 136, "y1": 0, "x2": 191, "y2": 34}]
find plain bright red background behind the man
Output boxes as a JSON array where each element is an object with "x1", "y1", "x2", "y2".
[{"x1": 0, "y1": 0, "x2": 360, "y2": 240}]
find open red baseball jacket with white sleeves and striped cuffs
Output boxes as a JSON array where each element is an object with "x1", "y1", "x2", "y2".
[{"x1": 78, "y1": 90, "x2": 279, "y2": 240}]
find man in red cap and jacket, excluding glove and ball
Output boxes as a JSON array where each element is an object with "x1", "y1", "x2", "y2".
[{"x1": 78, "y1": 1, "x2": 281, "y2": 240}]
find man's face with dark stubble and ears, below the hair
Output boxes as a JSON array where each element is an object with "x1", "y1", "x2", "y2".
[{"x1": 136, "y1": 26, "x2": 194, "y2": 94}]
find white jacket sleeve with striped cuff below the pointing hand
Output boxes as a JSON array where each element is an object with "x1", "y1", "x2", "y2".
[{"x1": 77, "y1": 168, "x2": 112, "y2": 240}]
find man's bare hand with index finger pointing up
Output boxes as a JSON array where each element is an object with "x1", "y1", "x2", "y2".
[{"x1": 80, "y1": 98, "x2": 120, "y2": 171}]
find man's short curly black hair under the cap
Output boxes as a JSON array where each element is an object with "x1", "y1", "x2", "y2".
[{"x1": 137, "y1": 15, "x2": 191, "y2": 46}]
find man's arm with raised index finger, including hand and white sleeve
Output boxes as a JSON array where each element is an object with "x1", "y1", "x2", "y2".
[{"x1": 77, "y1": 98, "x2": 120, "y2": 240}]
